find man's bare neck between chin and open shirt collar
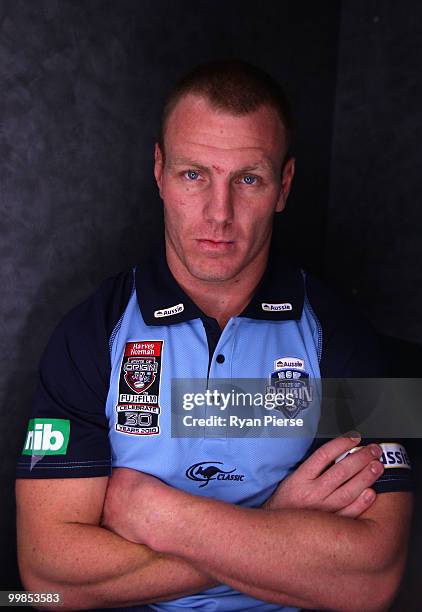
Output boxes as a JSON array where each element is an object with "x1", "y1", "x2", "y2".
[{"x1": 167, "y1": 246, "x2": 268, "y2": 329}]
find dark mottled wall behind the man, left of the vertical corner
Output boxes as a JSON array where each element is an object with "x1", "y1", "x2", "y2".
[{"x1": 0, "y1": 0, "x2": 339, "y2": 588}]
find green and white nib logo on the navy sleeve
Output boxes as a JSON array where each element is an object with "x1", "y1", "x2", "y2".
[{"x1": 22, "y1": 419, "x2": 70, "y2": 455}]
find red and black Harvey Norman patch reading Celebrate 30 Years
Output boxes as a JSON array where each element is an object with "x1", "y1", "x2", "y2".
[{"x1": 116, "y1": 340, "x2": 163, "y2": 436}]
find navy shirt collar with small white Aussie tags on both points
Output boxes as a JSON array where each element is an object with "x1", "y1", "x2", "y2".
[{"x1": 135, "y1": 241, "x2": 305, "y2": 325}]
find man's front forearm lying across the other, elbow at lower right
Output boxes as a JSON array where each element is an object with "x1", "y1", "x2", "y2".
[{"x1": 146, "y1": 492, "x2": 406, "y2": 610}]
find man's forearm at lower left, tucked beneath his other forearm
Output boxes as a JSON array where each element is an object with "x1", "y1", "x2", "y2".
[{"x1": 19, "y1": 523, "x2": 214, "y2": 610}]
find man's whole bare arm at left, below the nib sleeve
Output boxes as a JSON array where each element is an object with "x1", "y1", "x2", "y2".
[{"x1": 16, "y1": 477, "x2": 218, "y2": 610}]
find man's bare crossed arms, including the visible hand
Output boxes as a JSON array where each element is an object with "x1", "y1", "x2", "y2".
[{"x1": 17, "y1": 438, "x2": 412, "y2": 610}]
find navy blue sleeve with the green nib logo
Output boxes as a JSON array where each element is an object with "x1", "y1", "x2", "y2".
[{"x1": 17, "y1": 273, "x2": 133, "y2": 478}]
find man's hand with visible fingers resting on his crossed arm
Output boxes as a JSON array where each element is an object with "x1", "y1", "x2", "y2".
[{"x1": 264, "y1": 436, "x2": 384, "y2": 518}]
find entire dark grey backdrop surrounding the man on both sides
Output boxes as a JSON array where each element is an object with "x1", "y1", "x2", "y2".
[{"x1": 0, "y1": 0, "x2": 422, "y2": 610}]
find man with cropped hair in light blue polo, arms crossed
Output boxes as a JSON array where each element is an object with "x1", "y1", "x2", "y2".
[{"x1": 17, "y1": 61, "x2": 411, "y2": 611}]
